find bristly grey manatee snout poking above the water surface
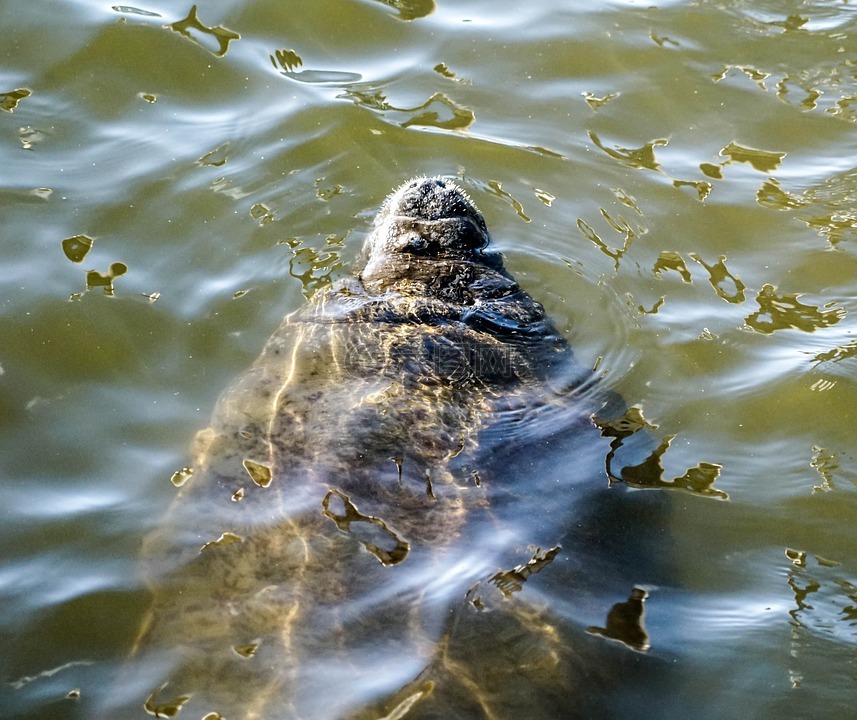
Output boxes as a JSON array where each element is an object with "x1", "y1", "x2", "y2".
[{"x1": 360, "y1": 177, "x2": 501, "y2": 292}]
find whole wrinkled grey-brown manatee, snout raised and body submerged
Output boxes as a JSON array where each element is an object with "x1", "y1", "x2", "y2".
[{"x1": 134, "y1": 178, "x2": 627, "y2": 720}]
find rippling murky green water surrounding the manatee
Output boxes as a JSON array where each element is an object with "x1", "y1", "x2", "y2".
[{"x1": 0, "y1": 0, "x2": 857, "y2": 718}]
